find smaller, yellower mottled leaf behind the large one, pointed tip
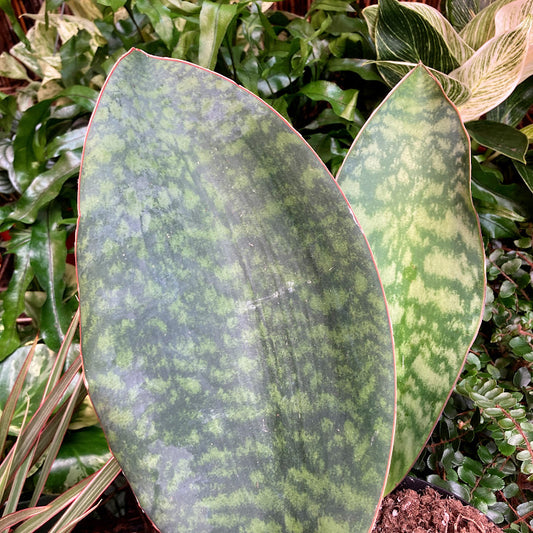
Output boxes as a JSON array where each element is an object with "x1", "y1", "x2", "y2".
[{"x1": 338, "y1": 66, "x2": 485, "y2": 489}]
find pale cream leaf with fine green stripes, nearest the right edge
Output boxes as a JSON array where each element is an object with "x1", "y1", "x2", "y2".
[{"x1": 450, "y1": 17, "x2": 532, "y2": 122}]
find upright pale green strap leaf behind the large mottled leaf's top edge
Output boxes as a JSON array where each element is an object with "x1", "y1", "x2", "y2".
[{"x1": 198, "y1": 0, "x2": 239, "y2": 69}]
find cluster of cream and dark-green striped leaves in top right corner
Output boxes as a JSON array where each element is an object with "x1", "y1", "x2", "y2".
[{"x1": 363, "y1": 0, "x2": 533, "y2": 122}]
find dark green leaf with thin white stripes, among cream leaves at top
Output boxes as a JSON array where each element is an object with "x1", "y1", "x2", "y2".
[{"x1": 375, "y1": 0, "x2": 460, "y2": 74}]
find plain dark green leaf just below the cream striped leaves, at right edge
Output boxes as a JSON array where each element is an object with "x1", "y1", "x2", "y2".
[{"x1": 466, "y1": 120, "x2": 529, "y2": 163}]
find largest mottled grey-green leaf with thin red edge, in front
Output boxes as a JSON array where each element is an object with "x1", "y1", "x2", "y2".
[{"x1": 77, "y1": 50, "x2": 395, "y2": 533}]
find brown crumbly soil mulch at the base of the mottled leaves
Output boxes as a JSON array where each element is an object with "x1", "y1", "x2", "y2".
[{"x1": 372, "y1": 487, "x2": 502, "y2": 533}]
